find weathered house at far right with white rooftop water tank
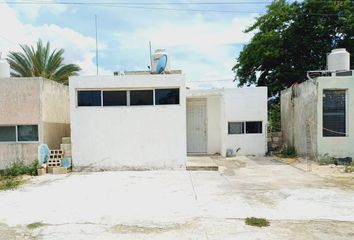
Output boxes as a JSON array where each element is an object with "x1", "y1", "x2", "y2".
[{"x1": 281, "y1": 49, "x2": 354, "y2": 158}]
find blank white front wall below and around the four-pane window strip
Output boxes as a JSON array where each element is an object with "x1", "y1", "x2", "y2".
[{"x1": 69, "y1": 74, "x2": 186, "y2": 169}]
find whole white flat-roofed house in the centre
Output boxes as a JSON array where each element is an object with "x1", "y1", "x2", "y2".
[{"x1": 69, "y1": 71, "x2": 267, "y2": 169}]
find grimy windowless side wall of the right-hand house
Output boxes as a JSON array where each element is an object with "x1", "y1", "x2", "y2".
[{"x1": 281, "y1": 80, "x2": 317, "y2": 157}]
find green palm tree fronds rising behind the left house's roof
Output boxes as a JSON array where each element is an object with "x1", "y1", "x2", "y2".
[{"x1": 7, "y1": 39, "x2": 81, "y2": 84}]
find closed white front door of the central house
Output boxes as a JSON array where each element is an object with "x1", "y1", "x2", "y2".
[{"x1": 187, "y1": 99, "x2": 207, "y2": 154}]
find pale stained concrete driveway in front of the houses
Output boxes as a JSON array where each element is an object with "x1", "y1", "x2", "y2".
[{"x1": 0, "y1": 157, "x2": 354, "y2": 240}]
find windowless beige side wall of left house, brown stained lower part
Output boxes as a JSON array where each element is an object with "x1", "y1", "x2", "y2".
[{"x1": 40, "y1": 79, "x2": 70, "y2": 149}]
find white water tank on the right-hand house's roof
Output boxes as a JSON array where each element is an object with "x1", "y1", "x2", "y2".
[{"x1": 327, "y1": 48, "x2": 350, "y2": 71}]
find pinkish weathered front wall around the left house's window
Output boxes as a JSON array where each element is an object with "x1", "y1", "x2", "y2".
[{"x1": 0, "y1": 78, "x2": 40, "y2": 169}]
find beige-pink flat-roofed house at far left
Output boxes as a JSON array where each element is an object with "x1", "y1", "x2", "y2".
[{"x1": 0, "y1": 77, "x2": 70, "y2": 169}]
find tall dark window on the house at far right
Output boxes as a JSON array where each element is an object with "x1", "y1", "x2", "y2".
[{"x1": 322, "y1": 90, "x2": 346, "y2": 137}]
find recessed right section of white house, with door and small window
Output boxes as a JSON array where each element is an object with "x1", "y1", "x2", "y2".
[{"x1": 187, "y1": 87, "x2": 267, "y2": 156}]
